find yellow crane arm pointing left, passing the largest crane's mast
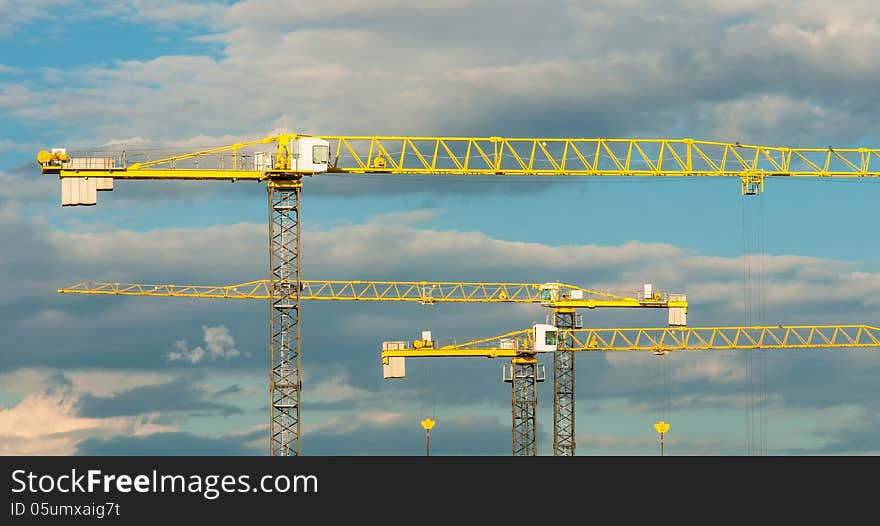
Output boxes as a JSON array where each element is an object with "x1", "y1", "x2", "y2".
[{"x1": 58, "y1": 280, "x2": 687, "y2": 310}]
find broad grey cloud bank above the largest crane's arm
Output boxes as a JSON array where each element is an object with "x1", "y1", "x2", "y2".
[{"x1": 6, "y1": 0, "x2": 880, "y2": 154}]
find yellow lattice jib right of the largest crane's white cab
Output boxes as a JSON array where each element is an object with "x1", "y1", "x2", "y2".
[{"x1": 321, "y1": 135, "x2": 880, "y2": 177}]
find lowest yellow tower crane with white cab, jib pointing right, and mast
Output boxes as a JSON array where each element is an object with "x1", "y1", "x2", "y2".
[{"x1": 382, "y1": 324, "x2": 880, "y2": 456}]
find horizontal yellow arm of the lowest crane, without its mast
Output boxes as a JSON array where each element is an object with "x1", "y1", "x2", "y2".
[{"x1": 382, "y1": 325, "x2": 880, "y2": 363}]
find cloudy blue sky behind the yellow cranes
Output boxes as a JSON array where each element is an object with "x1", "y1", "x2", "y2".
[{"x1": 0, "y1": 0, "x2": 880, "y2": 455}]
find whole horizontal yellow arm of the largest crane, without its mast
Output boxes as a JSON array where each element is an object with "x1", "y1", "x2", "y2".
[{"x1": 37, "y1": 134, "x2": 880, "y2": 192}]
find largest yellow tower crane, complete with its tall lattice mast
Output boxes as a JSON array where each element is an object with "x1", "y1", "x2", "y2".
[{"x1": 36, "y1": 133, "x2": 880, "y2": 455}]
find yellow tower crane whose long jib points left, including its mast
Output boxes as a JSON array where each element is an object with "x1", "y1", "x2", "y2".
[{"x1": 58, "y1": 280, "x2": 687, "y2": 456}]
